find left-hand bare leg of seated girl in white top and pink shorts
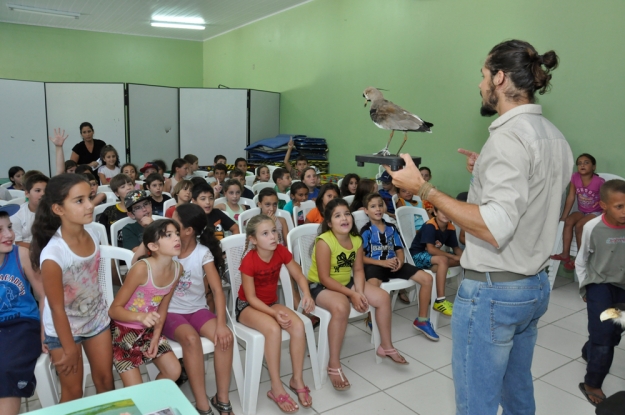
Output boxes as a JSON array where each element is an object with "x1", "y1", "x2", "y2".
[{"x1": 174, "y1": 319, "x2": 211, "y2": 411}]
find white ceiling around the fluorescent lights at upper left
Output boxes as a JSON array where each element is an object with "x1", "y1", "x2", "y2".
[{"x1": 0, "y1": 0, "x2": 311, "y2": 41}]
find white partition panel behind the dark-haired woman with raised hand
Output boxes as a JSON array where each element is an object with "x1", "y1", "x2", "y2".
[{"x1": 45, "y1": 83, "x2": 126, "y2": 174}]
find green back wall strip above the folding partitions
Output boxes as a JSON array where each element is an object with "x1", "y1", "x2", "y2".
[{"x1": 0, "y1": 23, "x2": 202, "y2": 87}]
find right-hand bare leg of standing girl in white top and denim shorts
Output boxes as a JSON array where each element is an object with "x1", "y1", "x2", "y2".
[{"x1": 83, "y1": 330, "x2": 115, "y2": 393}]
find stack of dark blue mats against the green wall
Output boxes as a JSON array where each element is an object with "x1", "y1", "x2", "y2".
[{"x1": 245, "y1": 134, "x2": 328, "y2": 164}]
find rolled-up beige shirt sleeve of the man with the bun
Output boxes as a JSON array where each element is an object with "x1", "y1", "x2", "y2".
[{"x1": 478, "y1": 133, "x2": 530, "y2": 248}]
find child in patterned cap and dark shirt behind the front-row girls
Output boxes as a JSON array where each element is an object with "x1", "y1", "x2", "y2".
[{"x1": 122, "y1": 190, "x2": 154, "y2": 252}]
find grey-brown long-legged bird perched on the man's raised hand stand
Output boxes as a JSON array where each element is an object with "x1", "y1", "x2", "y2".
[{"x1": 362, "y1": 87, "x2": 434, "y2": 156}]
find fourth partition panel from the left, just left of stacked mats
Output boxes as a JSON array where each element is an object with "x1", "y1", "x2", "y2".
[{"x1": 180, "y1": 88, "x2": 248, "y2": 165}]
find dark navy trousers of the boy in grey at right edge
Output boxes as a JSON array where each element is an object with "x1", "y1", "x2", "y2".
[{"x1": 582, "y1": 284, "x2": 625, "y2": 388}]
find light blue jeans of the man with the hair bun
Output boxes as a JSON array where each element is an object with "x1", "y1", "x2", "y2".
[{"x1": 451, "y1": 271, "x2": 550, "y2": 415}]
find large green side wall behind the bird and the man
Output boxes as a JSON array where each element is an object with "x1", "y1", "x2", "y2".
[{"x1": 203, "y1": 0, "x2": 625, "y2": 194}]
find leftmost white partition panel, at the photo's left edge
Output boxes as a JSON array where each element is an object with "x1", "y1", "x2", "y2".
[{"x1": 0, "y1": 79, "x2": 50, "y2": 177}]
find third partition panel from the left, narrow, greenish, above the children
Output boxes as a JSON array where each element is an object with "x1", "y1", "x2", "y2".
[{"x1": 128, "y1": 84, "x2": 179, "y2": 167}]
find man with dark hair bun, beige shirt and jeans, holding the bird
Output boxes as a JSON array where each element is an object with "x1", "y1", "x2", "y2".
[{"x1": 387, "y1": 40, "x2": 573, "y2": 415}]
